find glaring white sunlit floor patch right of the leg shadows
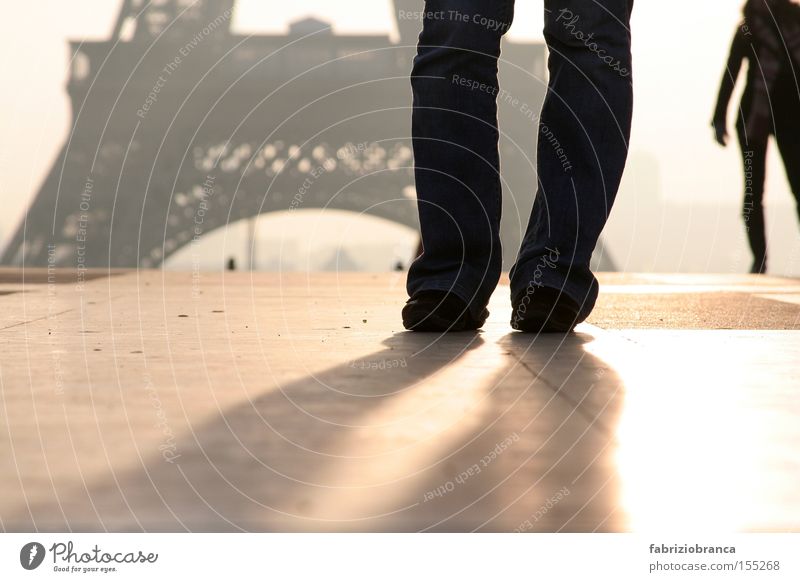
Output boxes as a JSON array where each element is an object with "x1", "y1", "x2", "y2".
[{"x1": 586, "y1": 331, "x2": 800, "y2": 532}]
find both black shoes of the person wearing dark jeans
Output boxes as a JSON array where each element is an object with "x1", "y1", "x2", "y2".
[{"x1": 403, "y1": 287, "x2": 581, "y2": 333}]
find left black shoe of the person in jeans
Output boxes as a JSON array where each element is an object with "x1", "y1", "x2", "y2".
[{"x1": 403, "y1": 291, "x2": 489, "y2": 331}]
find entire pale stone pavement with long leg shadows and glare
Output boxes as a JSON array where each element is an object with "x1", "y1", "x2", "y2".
[{"x1": 0, "y1": 269, "x2": 800, "y2": 532}]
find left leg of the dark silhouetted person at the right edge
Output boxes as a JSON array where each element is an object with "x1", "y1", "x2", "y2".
[{"x1": 737, "y1": 124, "x2": 767, "y2": 273}]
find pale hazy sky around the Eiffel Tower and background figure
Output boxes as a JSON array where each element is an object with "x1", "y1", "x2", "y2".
[{"x1": 0, "y1": 0, "x2": 792, "y2": 274}]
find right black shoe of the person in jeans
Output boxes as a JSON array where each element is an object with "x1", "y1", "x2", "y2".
[{"x1": 511, "y1": 287, "x2": 583, "y2": 333}]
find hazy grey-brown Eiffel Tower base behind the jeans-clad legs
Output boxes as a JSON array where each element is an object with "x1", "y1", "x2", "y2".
[{"x1": 2, "y1": 0, "x2": 546, "y2": 269}]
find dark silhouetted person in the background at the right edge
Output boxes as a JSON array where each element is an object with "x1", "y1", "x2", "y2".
[{"x1": 712, "y1": 0, "x2": 800, "y2": 273}]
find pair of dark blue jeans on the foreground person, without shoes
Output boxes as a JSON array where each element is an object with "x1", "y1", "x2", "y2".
[{"x1": 407, "y1": 0, "x2": 633, "y2": 320}]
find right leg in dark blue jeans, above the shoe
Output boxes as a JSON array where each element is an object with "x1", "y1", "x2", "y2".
[{"x1": 511, "y1": 0, "x2": 633, "y2": 321}]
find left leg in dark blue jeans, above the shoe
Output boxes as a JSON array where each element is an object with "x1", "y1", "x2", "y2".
[{"x1": 407, "y1": 0, "x2": 514, "y2": 318}]
